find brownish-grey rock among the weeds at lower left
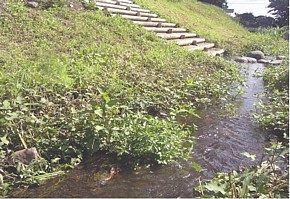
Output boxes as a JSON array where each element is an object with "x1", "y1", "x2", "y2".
[{"x1": 12, "y1": 147, "x2": 40, "y2": 164}]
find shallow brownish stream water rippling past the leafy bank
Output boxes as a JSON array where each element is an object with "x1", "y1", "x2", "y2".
[{"x1": 13, "y1": 64, "x2": 266, "y2": 197}]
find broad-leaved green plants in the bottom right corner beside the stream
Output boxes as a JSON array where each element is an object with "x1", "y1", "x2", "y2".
[{"x1": 196, "y1": 143, "x2": 289, "y2": 198}]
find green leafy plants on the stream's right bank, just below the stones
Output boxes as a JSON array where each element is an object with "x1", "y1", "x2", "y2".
[{"x1": 254, "y1": 60, "x2": 289, "y2": 137}]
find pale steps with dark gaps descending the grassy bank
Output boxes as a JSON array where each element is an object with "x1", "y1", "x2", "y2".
[{"x1": 88, "y1": 0, "x2": 224, "y2": 56}]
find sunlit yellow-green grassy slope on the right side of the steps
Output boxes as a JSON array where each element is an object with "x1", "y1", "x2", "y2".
[{"x1": 135, "y1": 0, "x2": 288, "y2": 54}]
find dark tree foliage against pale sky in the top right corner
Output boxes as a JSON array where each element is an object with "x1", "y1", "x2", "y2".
[{"x1": 268, "y1": 0, "x2": 289, "y2": 27}]
